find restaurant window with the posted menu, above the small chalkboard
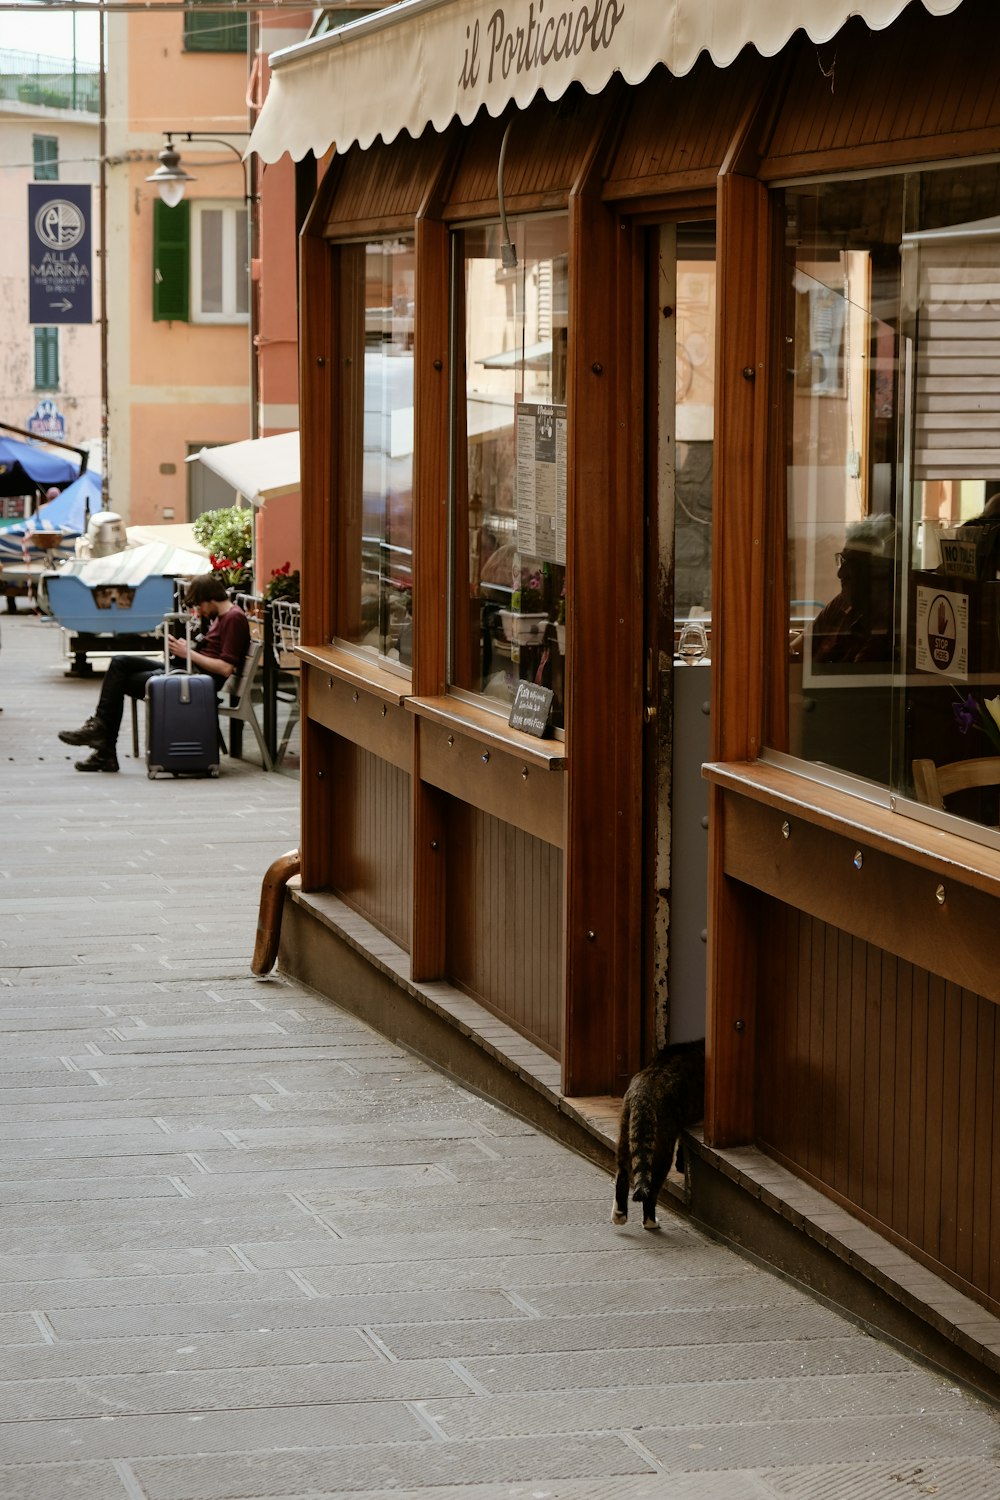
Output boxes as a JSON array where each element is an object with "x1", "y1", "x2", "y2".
[{"x1": 450, "y1": 215, "x2": 568, "y2": 728}]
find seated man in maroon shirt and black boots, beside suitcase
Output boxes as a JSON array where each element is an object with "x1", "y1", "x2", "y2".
[{"x1": 58, "y1": 573, "x2": 250, "y2": 771}]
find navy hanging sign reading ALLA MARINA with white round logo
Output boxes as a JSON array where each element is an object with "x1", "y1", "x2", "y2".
[{"x1": 28, "y1": 183, "x2": 93, "y2": 324}]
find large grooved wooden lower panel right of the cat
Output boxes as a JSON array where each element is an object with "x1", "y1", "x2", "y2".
[{"x1": 756, "y1": 900, "x2": 1000, "y2": 1311}]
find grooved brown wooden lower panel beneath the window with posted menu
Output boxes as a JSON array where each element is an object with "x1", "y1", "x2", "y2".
[{"x1": 447, "y1": 800, "x2": 564, "y2": 1058}]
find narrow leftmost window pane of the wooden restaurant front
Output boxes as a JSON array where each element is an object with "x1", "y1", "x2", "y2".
[{"x1": 337, "y1": 236, "x2": 415, "y2": 668}]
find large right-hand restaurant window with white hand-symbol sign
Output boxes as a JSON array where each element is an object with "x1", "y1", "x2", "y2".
[{"x1": 769, "y1": 165, "x2": 1000, "y2": 846}]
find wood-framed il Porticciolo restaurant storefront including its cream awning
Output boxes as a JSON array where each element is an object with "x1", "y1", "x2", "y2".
[{"x1": 252, "y1": 0, "x2": 1000, "y2": 1368}]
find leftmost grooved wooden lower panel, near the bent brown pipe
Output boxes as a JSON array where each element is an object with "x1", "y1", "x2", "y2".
[{"x1": 330, "y1": 735, "x2": 411, "y2": 948}]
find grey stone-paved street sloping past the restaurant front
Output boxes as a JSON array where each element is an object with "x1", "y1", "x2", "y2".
[{"x1": 0, "y1": 615, "x2": 1000, "y2": 1500}]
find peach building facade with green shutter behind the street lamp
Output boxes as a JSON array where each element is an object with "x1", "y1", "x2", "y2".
[{"x1": 106, "y1": 5, "x2": 252, "y2": 524}]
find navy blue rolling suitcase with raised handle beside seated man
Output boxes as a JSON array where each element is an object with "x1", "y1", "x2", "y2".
[{"x1": 145, "y1": 617, "x2": 219, "y2": 780}]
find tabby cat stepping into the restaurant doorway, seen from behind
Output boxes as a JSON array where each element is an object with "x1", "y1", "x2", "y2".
[{"x1": 612, "y1": 1037, "x2": 705, "y2": 1229}]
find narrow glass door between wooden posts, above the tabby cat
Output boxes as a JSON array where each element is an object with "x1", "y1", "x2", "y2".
[{"x1": 643, "y1": 222, "x2": 715, "y2": 1053}]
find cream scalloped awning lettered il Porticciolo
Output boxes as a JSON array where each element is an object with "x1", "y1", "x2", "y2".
[{"x1": 247, "y1": 0, "x2": 961, "y2": 162}]
